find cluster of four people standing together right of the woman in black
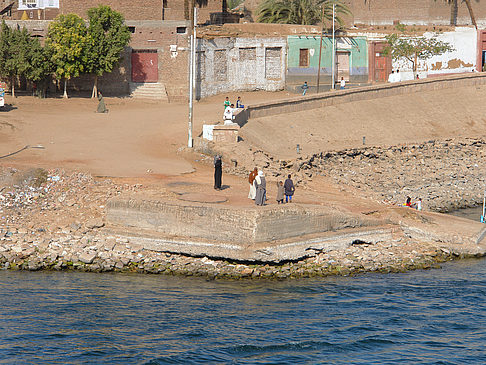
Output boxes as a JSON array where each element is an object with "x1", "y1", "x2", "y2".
[{"x1": 248, "y1": 167, "x2": 295, "y2": 205}]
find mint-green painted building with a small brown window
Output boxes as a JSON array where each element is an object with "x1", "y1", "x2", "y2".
[{"x1": 286, "y1": 35, "x2": 369, "y2": 89}]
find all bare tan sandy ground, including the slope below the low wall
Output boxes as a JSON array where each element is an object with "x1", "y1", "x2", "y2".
[{"x1": 0, "y1": 87, "x2": 486, "y2": 211}]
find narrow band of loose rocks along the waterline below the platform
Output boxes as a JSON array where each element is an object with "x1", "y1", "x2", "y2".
[{"x1": 0, "y1": 229, "x2": 474, "y2": 279}]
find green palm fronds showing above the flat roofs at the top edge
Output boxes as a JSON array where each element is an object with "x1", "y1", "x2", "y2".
[{"x1": 258, "y1": 0, "x2": 351, "y2": 26}]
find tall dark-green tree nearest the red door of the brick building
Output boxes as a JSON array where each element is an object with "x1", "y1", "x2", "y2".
[{"x1": 86, "y1": 5, "x2": 130, "y2": 98}]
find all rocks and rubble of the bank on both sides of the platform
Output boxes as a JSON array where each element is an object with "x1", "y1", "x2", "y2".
[{"x1": 0, "y1": 139, "x2": 486, "y2": 279}]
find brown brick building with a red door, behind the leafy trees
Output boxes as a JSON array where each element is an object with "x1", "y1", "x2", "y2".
[{"x1": 0, "y1": 0, "x2": 228, "y2": 100}]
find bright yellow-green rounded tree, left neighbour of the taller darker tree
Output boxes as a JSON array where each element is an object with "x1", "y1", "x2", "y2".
[{"x1": 46, "y1": 14, "x2": 89, "y2": 98}]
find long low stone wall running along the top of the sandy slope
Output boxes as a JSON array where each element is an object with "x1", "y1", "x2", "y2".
[{"x1": 235, "y1": 73, "x2": 486, "y2": 122}]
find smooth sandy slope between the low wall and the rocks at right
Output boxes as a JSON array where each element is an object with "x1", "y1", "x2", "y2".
[{"x1": 242, "y1": 86, "x2": 486, "y2": 159}]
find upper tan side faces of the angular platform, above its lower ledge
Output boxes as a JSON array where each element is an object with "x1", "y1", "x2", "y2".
[{"x1": 106, "y1": 198, "x2": 381, "y2": 244}]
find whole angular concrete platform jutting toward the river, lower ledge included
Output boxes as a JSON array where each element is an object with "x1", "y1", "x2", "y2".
[{"x1": 106, "y1": 195, "x2": 396, "y2": 262}]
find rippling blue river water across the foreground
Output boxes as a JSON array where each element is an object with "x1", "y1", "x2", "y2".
[{"x1": 0, "y1": 259, "x2": 486, "y2": 364}]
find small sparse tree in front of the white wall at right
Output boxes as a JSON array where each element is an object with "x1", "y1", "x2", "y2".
[{"x1": 383, "y1": 33, "x2": 454, "y2": 76}]
